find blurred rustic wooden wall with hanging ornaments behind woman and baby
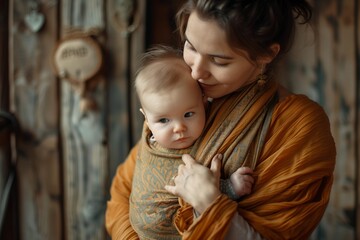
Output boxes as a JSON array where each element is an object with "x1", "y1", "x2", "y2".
[{"x1": 0, "y1": 0, "x2": 360, "y2": 240}]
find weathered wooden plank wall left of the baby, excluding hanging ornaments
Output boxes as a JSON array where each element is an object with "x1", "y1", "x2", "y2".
[{"x1": 4, "y1": 0, "x2": 146, "y2": 239}]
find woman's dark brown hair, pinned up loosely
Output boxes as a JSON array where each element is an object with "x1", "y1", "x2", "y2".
[{"x1": 176, "y1": 0, "x2": 312, "y2": 64}]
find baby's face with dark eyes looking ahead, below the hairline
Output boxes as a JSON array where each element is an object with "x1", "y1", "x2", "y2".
[{"x1": 142, "y1": 79, "x2": 205, "y2": 149}]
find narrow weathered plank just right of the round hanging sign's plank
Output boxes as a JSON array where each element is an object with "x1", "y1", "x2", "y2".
[{"x1": 106, "y1": 1, "x2": 131, "y2": 177}]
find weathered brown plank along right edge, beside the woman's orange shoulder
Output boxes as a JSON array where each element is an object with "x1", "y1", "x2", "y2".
[{"x1": 317, "y1": 1, "x2": 358, "y2": 239}]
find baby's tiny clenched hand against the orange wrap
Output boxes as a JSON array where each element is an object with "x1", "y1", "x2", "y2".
[{"x1": 230, "y1": 167, "x2": 254, "y2": 197}]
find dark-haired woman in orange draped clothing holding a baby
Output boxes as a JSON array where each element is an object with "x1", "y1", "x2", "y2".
[{"x1": 106, "y1": 0, "x2": 336, "y2": 239}]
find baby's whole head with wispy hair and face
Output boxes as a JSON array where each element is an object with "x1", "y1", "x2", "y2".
[{"x1": 135, "y1": 47, "x2": 205, "y2": 149}]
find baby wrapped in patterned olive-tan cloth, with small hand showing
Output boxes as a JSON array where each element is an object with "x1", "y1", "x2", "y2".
[{"x1": 130, "y1": 47, "x2": 253, "y2": 239}]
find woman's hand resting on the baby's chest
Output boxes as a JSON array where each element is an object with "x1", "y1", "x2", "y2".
[{"x1": 165, "y1": 154, "x2": 222, "y2": 214}]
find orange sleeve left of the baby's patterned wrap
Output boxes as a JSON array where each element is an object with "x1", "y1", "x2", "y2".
[{"x1": 105, "y1": 145, "x2": 139, "y2": 240}]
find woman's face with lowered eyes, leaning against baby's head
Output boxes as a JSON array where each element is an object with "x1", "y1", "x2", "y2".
[{"x1": 184, "y1": 12, "x2": 260, "y2": 98}]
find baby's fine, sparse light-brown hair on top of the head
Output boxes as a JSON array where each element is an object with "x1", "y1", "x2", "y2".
[{"x1": 135, "y1": 45, "x2": 191, "y2": 99}]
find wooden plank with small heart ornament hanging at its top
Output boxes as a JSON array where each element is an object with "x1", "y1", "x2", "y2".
[{"x1": 9, "y1": 0, "x2": 62, "y2": 239}]
